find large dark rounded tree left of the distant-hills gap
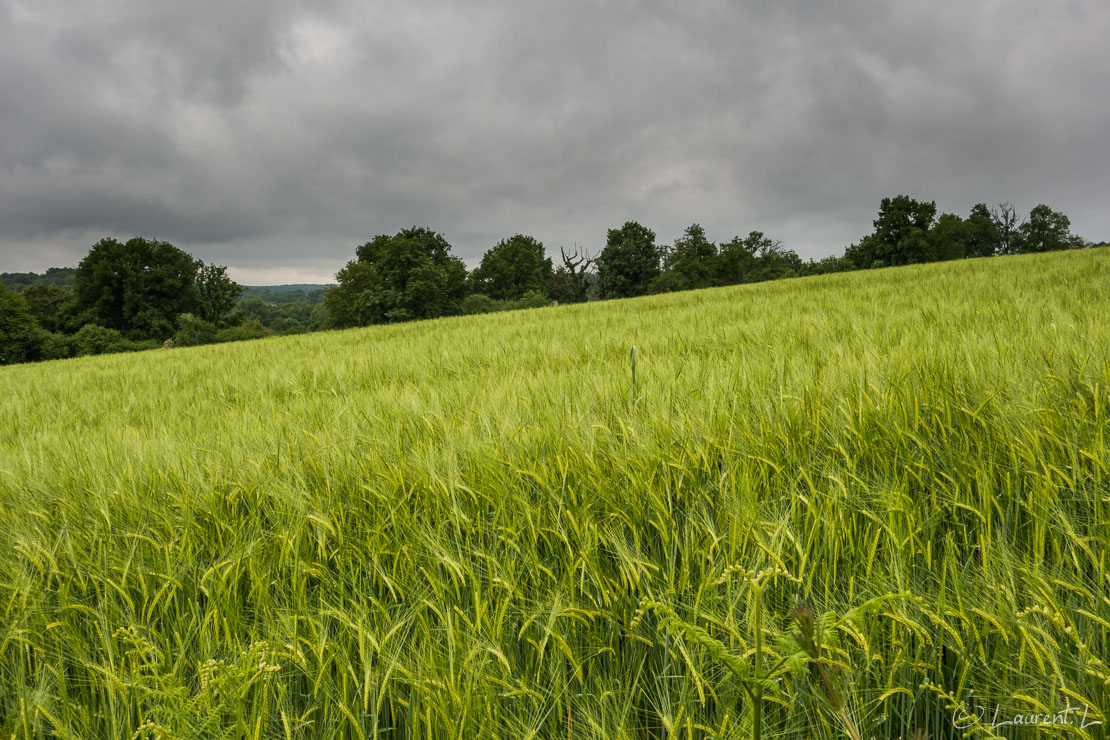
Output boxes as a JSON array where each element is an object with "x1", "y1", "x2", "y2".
[{"x1": 74, "y1": 237, "x2": 199, "y2": 341}]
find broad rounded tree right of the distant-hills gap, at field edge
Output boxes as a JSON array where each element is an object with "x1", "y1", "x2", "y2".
[{"x1": 324, "y1": 226, "x2": 466, "y2": 328}]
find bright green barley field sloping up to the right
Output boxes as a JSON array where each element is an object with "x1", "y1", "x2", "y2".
[{"x1": 0, "y1": 249, "x2": 1110, "y2": 740}]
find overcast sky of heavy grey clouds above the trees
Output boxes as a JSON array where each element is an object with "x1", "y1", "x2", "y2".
[{"x1": 0, "y1": 0, "x2": 1110, "y2": 284}]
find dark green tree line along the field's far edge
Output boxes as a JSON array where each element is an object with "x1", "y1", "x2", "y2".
[{"x1": 0, "y1": 195, "x2": 1096, "y2": 364}]
